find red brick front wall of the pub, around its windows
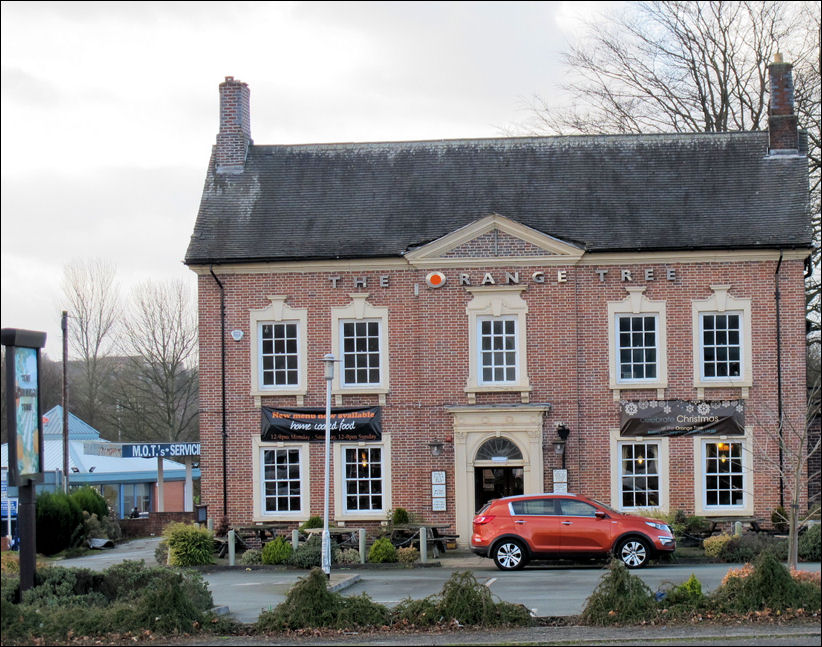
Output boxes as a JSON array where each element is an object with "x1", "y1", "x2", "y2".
[{"x1": 199, "y1": 256, "x2": 805, "y2": 539}]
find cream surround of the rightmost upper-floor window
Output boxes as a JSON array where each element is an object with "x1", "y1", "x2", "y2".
[{"x1": 691, "y1": 284, "x2": 753, "y2": 399}]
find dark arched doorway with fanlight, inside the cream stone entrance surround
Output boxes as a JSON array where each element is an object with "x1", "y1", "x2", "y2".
[{"x1": 474, "y1": 437, "x2": 525, "y2": 512}]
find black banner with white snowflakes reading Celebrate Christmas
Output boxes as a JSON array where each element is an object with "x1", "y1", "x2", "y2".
[{"x1": 619, "y1": 400, "x2": 745, "y2": 436}]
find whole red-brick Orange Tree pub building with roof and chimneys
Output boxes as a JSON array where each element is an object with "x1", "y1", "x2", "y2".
[{"x1": 186, "y1": 62, "x2": 811, "y2": 545}]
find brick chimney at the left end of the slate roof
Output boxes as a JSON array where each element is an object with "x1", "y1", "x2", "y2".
[{"x1": 217, "y1": 76, "x2": 253, "y2": 173}]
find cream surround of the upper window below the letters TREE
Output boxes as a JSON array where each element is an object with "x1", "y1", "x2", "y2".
[{"x1": 608, "y1": 286, "x2": 668, "y2": 400}]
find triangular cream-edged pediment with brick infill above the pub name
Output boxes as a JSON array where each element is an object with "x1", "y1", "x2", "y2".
[{"x1": 405, "y1": 214, "x2": 584, "y2": 268}]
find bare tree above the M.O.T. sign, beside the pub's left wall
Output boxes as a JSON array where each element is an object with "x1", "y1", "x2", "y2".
[{"x1": 116, "y1": 281, "x2": 198, "y2": 441}]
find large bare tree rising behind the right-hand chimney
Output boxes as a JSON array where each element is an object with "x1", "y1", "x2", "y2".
[{"x1": 526, "y1": 0, "x2": 822, "y2": 354}]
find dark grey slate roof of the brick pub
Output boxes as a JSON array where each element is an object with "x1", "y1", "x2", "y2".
[{"x1": 185, "y1": 132, "x2": 811, "y2": 264}]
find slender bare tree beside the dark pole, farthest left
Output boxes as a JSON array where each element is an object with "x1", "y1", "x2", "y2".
[{"x1": 63, "y1": 260, "x2": 120, "y2": 427}]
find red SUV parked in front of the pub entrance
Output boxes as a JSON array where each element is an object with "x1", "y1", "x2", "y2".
[{"x1": 471, "y1": 494, "x2": 676, "y2": 571}]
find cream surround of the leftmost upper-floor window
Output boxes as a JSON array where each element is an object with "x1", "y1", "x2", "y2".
[{"x1": 249, "y1": 295, "x2": 308, "y2": 406}]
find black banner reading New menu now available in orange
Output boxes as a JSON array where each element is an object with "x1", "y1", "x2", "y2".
[{"x1": 261, "y1": 407, "x2": 382, "y2": 441}]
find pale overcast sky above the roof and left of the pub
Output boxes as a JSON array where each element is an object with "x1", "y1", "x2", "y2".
[{"x1": 0, "y1": 2, "x2": 598, "y2": 359}]
